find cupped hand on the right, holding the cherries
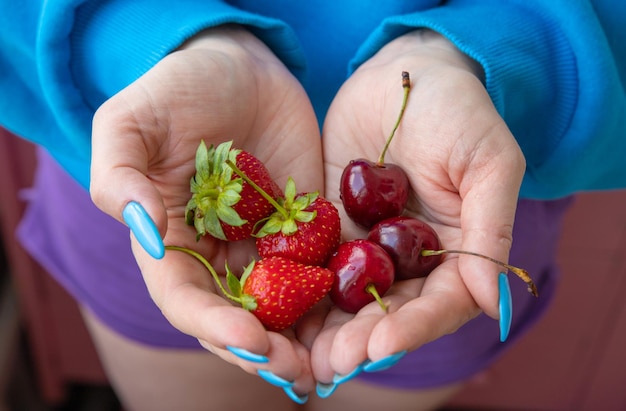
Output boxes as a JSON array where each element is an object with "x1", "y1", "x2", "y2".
[{"x1": 310, "y1": 30, "x2": 525, "y2": 383}]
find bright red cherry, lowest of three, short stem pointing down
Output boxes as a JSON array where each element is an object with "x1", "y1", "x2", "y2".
[{"x1": 326, "y1": 239, "x2": 394, "y2": 313}]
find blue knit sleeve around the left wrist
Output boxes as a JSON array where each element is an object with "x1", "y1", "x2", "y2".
[{"x1": 0, "y1": 0, "x2": 304, "y2": 187}]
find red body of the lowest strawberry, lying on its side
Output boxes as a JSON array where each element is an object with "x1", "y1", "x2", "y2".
[{"x1": 235, "y1": 257, "x2": 334, "y2": 331}]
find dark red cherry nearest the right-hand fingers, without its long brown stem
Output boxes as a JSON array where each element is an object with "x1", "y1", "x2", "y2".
[{"x1": 367, "y1": 216, "x2": 442, "y2": 281}]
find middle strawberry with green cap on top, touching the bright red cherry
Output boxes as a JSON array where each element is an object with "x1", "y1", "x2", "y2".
[{"x1": 255, "y1": 178, "x2": 341, "y2": 266}]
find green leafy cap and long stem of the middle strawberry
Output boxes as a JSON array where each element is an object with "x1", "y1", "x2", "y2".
[{"x1": 226, "y1": 160, "x2": 319, "y2": 237}]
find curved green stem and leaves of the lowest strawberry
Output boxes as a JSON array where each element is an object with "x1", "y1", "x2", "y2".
[{"x1": 165, "y1": 245, "x2": 257, "y2": 311}]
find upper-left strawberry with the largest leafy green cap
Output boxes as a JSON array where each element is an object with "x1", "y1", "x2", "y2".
[{"x1": 185, "y1": 141, "x2": 282, "y2": 241}]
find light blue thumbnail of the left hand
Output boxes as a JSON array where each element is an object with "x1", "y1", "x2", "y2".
[{"x1": 122, "y1": 201, "x2": 165, "y2": 260}]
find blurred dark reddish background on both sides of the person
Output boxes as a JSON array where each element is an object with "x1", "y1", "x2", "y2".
[{"x1": 0, "y1": 129, "x2": 626, "y2": 411}]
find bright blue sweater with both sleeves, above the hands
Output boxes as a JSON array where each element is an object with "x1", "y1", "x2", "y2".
[{"x1": 0, "y1": 0, "x2": 626, "y2": 199}]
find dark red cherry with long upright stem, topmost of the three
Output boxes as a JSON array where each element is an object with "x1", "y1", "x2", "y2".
[{"x1": 339, "y1": 71, "x2": 411, "y2": 228}]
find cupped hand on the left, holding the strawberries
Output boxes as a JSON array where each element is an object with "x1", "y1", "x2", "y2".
[{"x1": 91, "y1": 27, "x2": 324, "y2": 391}]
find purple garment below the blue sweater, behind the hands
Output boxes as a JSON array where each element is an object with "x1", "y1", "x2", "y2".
[{"x1": 18, "y1": 149, "x2": 571, "y2": 388}]
